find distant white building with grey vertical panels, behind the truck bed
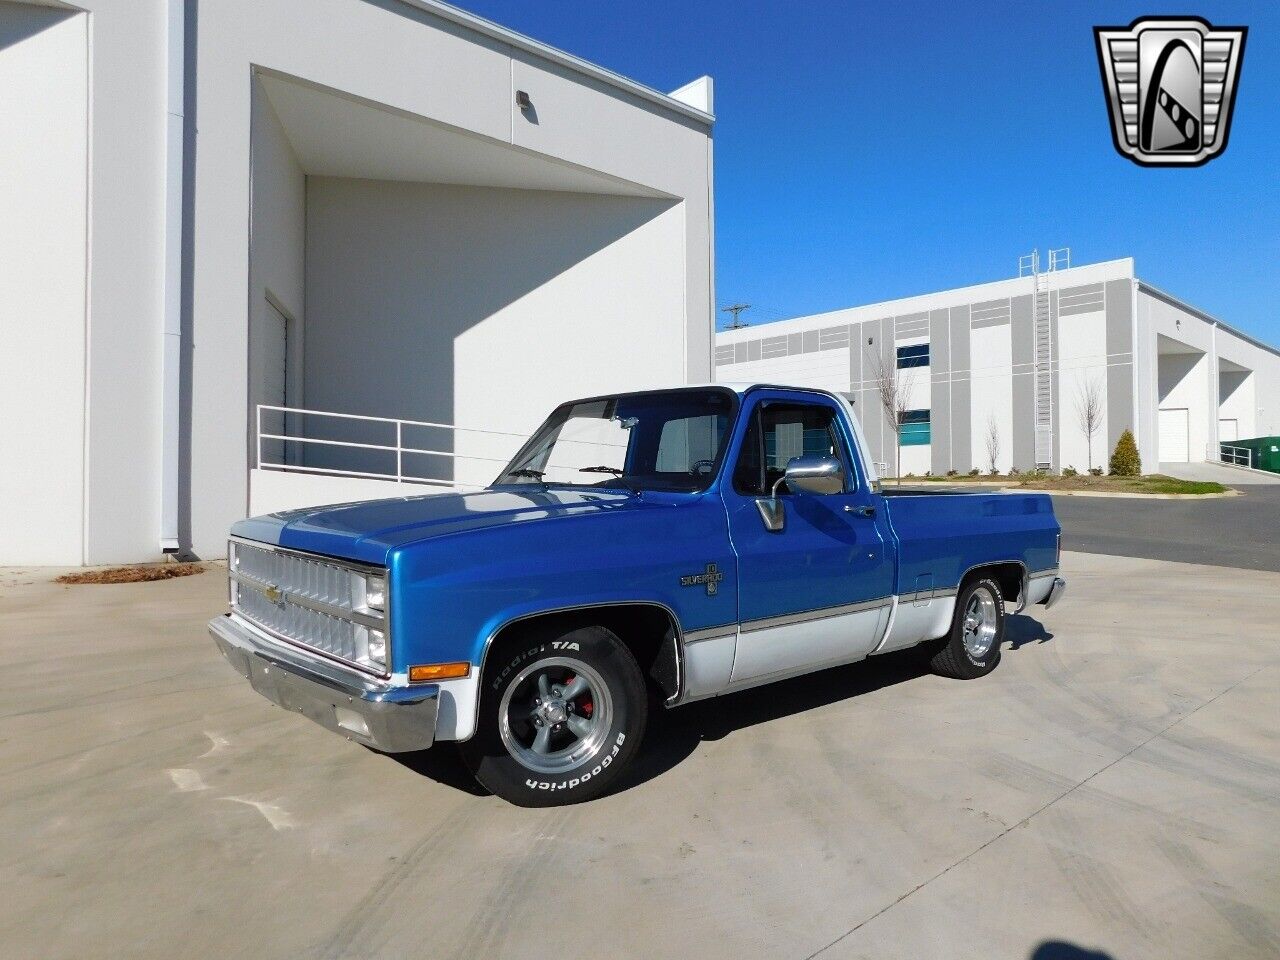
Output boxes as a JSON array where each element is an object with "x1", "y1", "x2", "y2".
[{"x1": 716, "y1": 260, "x2": 1280, "y2": 475}]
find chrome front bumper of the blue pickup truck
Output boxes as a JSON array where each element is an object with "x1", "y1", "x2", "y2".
[{"x1": 209, "y1": 614, "x2": 440, "y2": 754}]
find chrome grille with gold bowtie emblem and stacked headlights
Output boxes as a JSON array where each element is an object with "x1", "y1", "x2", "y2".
[{"x1": 230, "y1": 540, "x2": 380, "y2": 671}]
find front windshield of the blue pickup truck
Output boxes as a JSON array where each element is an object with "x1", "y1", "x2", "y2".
[{"x1": 494, "y1": 389, "x2": 736, "y2": 493}]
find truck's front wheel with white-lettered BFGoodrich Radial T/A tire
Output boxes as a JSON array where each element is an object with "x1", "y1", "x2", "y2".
[{"x1": 462, "y1": 626, "x2": 648, "y2": 806}]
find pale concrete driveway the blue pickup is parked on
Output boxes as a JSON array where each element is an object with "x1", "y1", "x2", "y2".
[{"x1": 0, "y1": 554, "x2": 1280, "y2": 960}]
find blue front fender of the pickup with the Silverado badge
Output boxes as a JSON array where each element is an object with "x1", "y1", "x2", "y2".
[{"x1": 389, "y1": 495, "x2": 737, "y2": 739}]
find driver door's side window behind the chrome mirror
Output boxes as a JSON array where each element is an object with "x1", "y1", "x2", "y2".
[{"x1": 733, "y1": 403, "x2": 850, "y2": 497}]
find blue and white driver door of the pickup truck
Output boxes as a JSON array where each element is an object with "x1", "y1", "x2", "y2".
[{"x1": 724, "y1": 392, "x2": 893, "y2": 684}]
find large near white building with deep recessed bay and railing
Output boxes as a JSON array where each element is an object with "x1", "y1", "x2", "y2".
[{"x1": 0, "y1": 0, "x2": 713, "y2": 564}]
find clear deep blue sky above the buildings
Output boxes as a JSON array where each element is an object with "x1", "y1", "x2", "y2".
[{"x1": 461, "y1": 0, "x2": 1280, "y2": 346}]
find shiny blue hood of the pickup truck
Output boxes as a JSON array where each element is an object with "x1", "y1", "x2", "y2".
[{"x1": 232, "y1": 486, "x2": 645, "y2": 564}]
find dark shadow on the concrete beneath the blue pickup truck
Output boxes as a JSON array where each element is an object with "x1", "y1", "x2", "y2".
[{"x1": 389, "y1": 614, "x2": 1053, "y2": 796}]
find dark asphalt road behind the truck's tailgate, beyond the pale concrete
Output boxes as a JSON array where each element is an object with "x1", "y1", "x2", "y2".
[{"x1": 1053, "y1": 484, "x2": 1280, "y2": 571}]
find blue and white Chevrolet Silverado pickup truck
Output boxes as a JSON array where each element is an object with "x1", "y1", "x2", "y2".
[{"x1": 209, "y1": 385, "x2": 1065, "y2": 806}]
